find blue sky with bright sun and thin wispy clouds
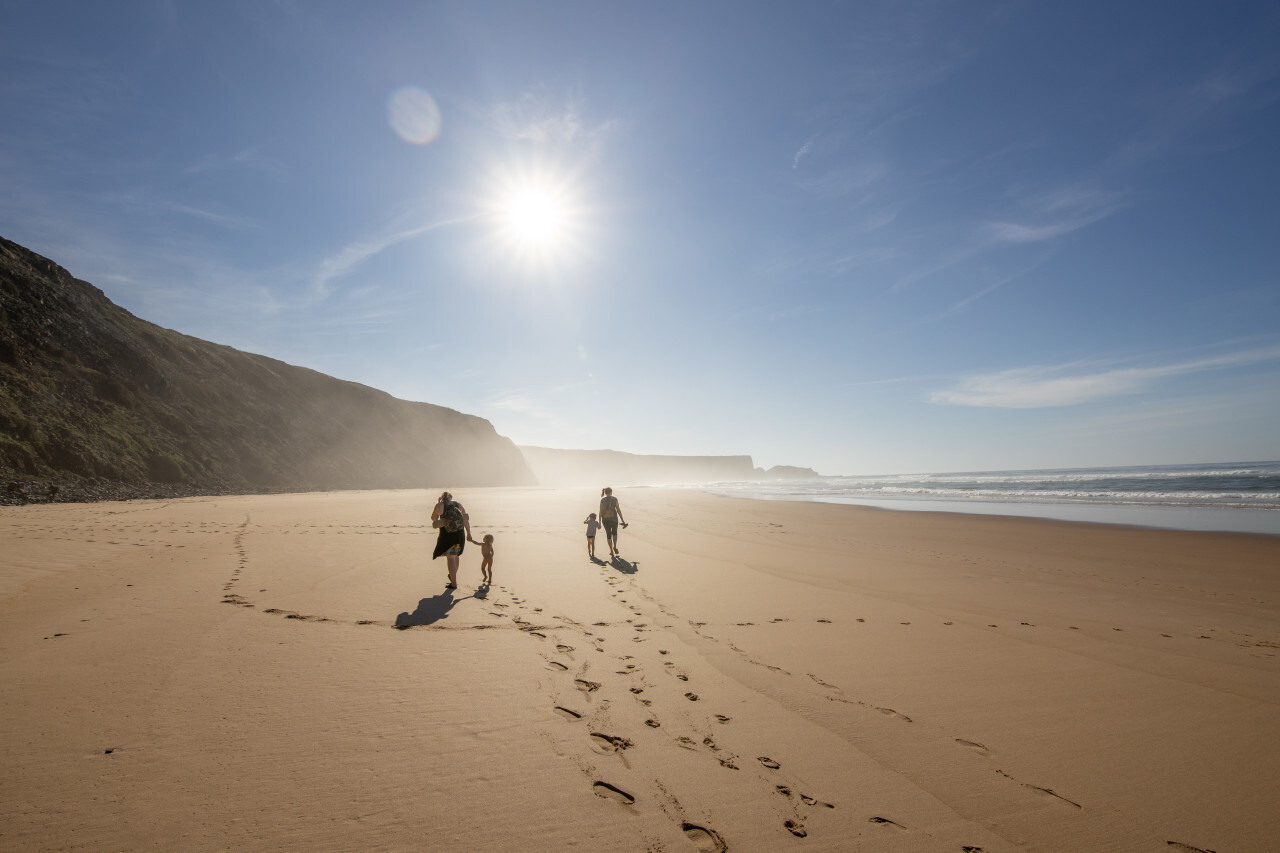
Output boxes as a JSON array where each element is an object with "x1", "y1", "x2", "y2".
[{"x1": 0, "y1": 0, "x2": 1280, "y2": 474}]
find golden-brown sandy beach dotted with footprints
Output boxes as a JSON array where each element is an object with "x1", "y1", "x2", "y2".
[{"x1": 0, "y1": 489, "x2": 1280, "y2": 853}]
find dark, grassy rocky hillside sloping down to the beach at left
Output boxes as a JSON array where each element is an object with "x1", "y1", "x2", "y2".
[{"x1": 0, "y1": 238, "x2": 534, "y2": 502}]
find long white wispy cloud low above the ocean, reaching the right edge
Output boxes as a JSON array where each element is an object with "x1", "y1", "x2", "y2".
[{"x1": 929, "y1": 346, "x2": 1280, "y2": 409}]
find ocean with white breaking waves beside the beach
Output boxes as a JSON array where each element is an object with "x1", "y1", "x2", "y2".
[{"x1": 703, "y1": 461, "x2": 1280, "y2": 535}]
